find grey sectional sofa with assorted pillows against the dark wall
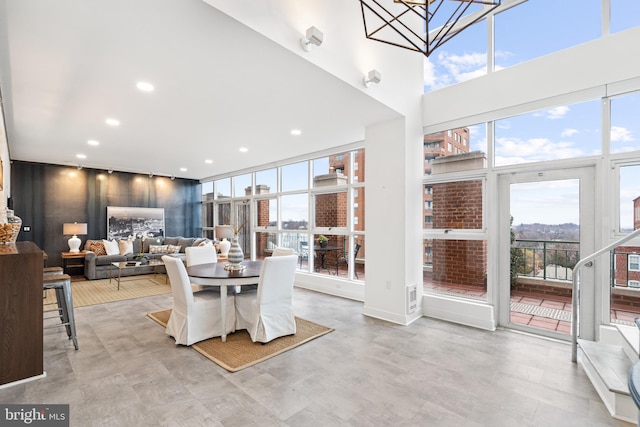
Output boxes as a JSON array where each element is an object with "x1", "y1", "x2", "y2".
[{"x1": 84, "y1": 237, "x2": 214, "y2": 280}]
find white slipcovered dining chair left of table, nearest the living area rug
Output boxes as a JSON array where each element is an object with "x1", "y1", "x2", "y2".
[{"x1": 162, "y1": 255, "x2": 236, "y2": 345}]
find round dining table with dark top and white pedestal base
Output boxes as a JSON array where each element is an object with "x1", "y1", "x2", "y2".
[{"x1": 187, "y1": 261, "x2": 263, "y2": 342}]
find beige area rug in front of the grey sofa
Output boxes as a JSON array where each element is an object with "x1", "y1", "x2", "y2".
[{"x1": 43, "y1": 274, "x2": 171, "y2": 311}]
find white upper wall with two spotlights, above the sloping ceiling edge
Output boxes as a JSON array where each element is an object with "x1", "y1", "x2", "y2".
[{"x1": 203, "y1": 0, "x2": 423, "y2": 117}]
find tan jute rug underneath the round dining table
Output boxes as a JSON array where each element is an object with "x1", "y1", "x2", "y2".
[{"x1": 147, "y1": 309, "x2": 333, "y2": 372}]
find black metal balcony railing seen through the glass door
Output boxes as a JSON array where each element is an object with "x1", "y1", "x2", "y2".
[{"x1": 511, "y1": 239, "x2": 580, "y2": 281}]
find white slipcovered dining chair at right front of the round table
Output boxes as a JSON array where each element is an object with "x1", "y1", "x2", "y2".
[{"x1": 235, "y1": 255, "x2": 298, "y2": 343}]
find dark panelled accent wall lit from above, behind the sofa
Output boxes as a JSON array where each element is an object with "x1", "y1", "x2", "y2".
[{"x1": 10, "y1": 161, "x2": 202, "y2": 266}]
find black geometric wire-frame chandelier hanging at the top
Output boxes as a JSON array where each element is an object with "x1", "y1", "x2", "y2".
[{"x1": 360, "y1": 0, "x2": 501, "y2": 57}]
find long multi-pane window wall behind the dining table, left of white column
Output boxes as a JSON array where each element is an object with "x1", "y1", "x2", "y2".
[{"x1": 203, "y1": 149, "x2": 366, "y2": 281}]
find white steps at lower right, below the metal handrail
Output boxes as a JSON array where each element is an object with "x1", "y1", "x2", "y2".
[{"x1": 578, "y1": 325, "x2": 640, "y2": 424}]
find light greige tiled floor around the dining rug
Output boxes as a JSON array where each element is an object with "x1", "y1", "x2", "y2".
[{"x1": 0, "y1": 289, "x2": 631, "y2": 427}]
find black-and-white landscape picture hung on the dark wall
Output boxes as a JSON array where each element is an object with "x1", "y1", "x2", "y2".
[{"x1": 107, "y1": 206, "x2": 164, "y2": 239}]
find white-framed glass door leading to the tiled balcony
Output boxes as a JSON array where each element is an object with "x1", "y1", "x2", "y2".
[{"x1": 499, "y1": 168, "x2": 597, "y2": 340}]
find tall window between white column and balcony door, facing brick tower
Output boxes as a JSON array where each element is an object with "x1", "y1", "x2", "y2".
[{"x1": 422, "y1": 124, "x2": 488, "y2": 301}]
